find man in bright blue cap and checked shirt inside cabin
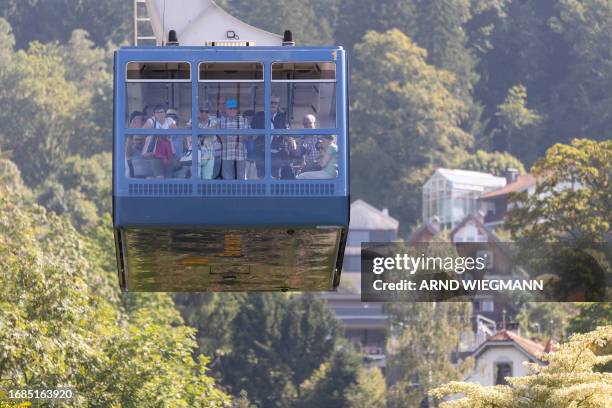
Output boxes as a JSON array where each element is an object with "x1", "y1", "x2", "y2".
[{"x1": 219, "y1": 99, "x2": 249, "y2": 180}]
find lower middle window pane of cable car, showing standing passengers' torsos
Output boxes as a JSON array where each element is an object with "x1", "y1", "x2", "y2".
[{"x1": 198, "y1": 135, "x2": 265, "y2": 180}]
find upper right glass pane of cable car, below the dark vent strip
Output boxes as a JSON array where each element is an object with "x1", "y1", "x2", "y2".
[{"x1": 271, "y1": 82, "x2": 336, "y2": 129}]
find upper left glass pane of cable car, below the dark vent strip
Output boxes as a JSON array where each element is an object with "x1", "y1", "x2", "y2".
[{"x1": 125, "y1": 82, "x2": 191, "y2": 128}]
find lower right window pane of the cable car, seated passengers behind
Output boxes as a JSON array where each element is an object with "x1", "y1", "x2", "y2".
[{"x1": 270, "y1": 135, "x2": 338, "y2": 180}]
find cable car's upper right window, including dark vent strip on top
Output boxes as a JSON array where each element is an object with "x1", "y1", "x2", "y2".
[{"x1": 271, "y1": 62, "x2": 336, "y2": 129}]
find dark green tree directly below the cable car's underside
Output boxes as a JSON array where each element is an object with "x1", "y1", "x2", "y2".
[{"x1": 221, "y1": 294, "x2": 354, "y2": 407}]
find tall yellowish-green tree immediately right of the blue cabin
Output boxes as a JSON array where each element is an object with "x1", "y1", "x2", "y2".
[{"x1": 351, "y1": 30, "x2": 472, "y2": 227}]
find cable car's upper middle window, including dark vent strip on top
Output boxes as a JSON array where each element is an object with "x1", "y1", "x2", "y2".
[{"x1": 198, "y1": 62, "x2": 264, "y2": 122}]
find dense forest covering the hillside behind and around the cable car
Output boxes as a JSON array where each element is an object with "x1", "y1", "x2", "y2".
[{"x1": 0, "y1": 0, "x2": 612, "y2": 407}]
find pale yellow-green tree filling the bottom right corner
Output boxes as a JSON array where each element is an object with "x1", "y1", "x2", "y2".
[{"x1": 431, "y1": 326, "x2": 612, "y2": 408}]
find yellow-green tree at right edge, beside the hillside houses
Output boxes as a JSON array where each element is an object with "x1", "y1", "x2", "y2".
[{"x1": 507, "y1": 139, "x2": 612, "y2": 244}]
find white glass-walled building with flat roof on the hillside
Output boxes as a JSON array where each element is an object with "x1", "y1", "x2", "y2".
[{"x1": 423, "y1": 169, "x2": 506, "y2": 228}]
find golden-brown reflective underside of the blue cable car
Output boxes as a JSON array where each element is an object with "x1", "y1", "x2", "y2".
[{"x1": 122, "y1": 228, "x2": 341, "y2": 292}]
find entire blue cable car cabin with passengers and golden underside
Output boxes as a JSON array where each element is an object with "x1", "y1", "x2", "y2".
[{"x1": 113, "y1": 47, "x2": 349, "y2": 292}]
